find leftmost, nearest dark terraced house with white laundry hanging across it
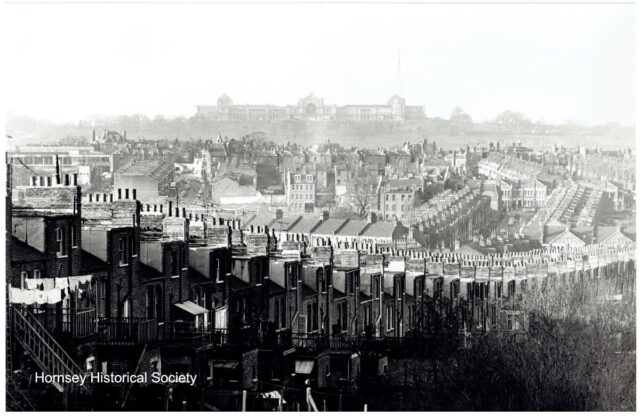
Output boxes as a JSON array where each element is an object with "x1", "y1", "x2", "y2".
[{"x1": 6, "y1": 171, "x2": 98, "y2": 409}]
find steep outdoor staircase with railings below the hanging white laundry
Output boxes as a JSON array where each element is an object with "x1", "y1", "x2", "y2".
[{"x1": 11, "y1": 305, "x2": 90, "y2": 394}]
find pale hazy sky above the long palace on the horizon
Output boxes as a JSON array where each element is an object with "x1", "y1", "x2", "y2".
[{"x1": 4, "y1": 4, "x2": 635, "y2": 125}]
